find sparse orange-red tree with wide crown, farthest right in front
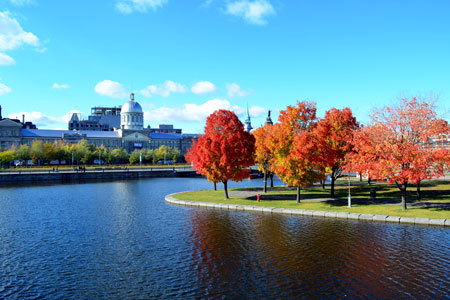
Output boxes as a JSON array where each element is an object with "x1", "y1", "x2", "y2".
[{"x1": 348, "y1": 98, "x2": 443, "y2": 210}]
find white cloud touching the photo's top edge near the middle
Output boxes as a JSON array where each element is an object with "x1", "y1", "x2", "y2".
[{"x1": 226, "y1": 0, "x2": 275, "y2": 25}]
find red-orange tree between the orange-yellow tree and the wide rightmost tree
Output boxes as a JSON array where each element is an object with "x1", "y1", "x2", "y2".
[{"x1": 313, "y1": 107, "x2": 358, "y2": 198}]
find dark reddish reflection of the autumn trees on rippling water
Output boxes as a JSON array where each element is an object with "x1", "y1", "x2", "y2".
[{"x1": 190, "y1": 209, "x2": 450, "y2": 299}]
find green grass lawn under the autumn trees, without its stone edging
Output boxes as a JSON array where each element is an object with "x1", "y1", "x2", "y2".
[{"x1": 174, "y1": 180, "x2": 450, "y2": 219}]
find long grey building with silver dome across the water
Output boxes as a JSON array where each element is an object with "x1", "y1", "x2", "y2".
[{"x1": 0, "y1": 94, "x2": 198, "y2": 154}]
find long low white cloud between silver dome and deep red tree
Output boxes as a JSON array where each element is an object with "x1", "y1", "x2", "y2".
[{"x1": 144, "y1": 99, "x2": 267, "y2": 122}]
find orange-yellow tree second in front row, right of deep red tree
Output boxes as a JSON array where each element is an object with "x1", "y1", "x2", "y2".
[{"x1": 270, "y1": 101, "x2": 324, "y2": 203}]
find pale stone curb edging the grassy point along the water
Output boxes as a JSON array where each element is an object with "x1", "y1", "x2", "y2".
[{"x1": 165, "y1": 194, "x2": 450, "y2": 227}]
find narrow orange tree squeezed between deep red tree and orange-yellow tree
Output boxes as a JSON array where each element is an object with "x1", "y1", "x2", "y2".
[{"x1": 252, "y1": 123, "x2": 274, "y2": 193}]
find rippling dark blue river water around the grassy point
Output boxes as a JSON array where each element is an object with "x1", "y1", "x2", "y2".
[{"x1": 0, "y1": 178, "x2": 450, "y2": 299}]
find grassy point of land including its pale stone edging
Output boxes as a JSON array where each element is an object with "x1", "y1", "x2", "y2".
[{"x1": 166, "y1": 180, "x2": 450, "y2": 226}]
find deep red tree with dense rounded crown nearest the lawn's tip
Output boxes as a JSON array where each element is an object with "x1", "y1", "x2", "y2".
[{"x1": 186, "y1": 109, "x2": 255, "y2": 199}]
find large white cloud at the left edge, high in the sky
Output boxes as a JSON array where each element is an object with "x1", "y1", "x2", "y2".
[{"x1": 0, "y1": 11, "x2": 39, "y2": 51}]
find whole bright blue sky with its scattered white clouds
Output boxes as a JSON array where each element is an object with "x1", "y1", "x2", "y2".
[{"x1": 0, "y1": 0, "x2": 450, "y2": 132}]
